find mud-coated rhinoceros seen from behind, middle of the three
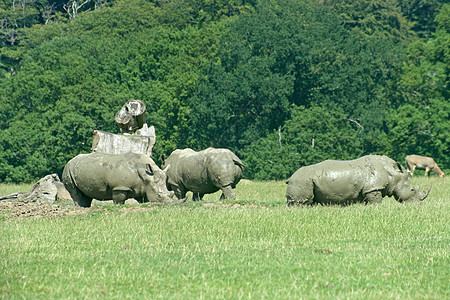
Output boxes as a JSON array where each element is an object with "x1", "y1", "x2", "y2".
[{"x1": 161, "y1": 148, "x2": 244, "y2": 201}]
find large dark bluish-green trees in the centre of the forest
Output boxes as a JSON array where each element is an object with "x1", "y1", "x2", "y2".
[{"x1": 189, "y1": 1, "x2": 402, "y2": 154}]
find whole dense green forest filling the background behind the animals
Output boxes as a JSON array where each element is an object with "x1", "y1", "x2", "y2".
[{"x1": 0, "y1": 0, "x2": 450, "y2": 183}]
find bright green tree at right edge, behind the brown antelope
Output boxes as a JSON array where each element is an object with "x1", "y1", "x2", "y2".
[{"x1": 389, "y1": 5, "x2": 450, "y2": 168}]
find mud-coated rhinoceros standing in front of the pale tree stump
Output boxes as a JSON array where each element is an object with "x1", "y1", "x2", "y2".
[{"x1": 62, "y1": 152, "x2": 181, "y2": 207}]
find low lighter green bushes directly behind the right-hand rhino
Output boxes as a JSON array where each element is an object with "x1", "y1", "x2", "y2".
[{"x1": 243, "y1": 107, "x2": 365, "y2": 180}]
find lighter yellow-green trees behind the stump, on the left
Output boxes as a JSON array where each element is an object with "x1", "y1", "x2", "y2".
[{"x1": 0, "y1": 1, "x2": 226, "y2": 182}]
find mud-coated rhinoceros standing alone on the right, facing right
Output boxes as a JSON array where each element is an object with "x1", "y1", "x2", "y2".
[{"x1": 286, "y1": 155, "x2": 431, "y2": 205}]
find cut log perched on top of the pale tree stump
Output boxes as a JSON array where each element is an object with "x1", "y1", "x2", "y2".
[{"x1": 114, "y1": 100, "x2": 145, "y2": 133}]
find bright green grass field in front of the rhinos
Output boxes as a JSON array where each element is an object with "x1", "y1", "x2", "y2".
[{"x1": 0, "y1": 177, "x2": 450, "y2": 299}]
